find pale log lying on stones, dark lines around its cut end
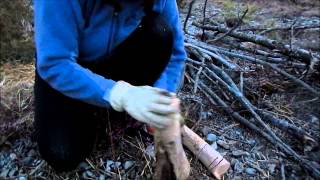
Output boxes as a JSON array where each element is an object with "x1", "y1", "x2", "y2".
[{"x1": 182, "y1": 126, "x2": 230, "y2": 179}]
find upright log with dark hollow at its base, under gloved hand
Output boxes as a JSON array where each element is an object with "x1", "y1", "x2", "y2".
[{"x1": 154, "y1": 114, "x2": 190, "y2": 180}]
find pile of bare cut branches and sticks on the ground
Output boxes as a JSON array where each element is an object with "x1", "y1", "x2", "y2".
[{"x1": 184, "y1": 1, "x2": 320, "y2": 178}]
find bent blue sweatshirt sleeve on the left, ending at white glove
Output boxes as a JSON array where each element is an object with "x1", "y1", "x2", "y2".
[{"x1": 34, "y1": 0, "x2": 115, "y2": 107}]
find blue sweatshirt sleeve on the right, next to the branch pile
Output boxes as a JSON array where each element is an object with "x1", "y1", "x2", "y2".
[{"x1": 154, "y1": 0, "x2": 186, "y2": 92}]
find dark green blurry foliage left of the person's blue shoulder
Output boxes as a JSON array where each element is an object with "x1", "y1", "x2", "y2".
[{"x1": 0, "y1": 0, "x2": 34, "y2": 64}]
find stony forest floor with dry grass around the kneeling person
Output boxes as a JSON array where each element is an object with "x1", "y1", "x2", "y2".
[{"x1": 0, "y1": 0, "x2": 320, "y2": 180}]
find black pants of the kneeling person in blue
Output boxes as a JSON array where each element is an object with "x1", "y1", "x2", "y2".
[{"x1": 35, "y1": 13, "x2": 173, "y2": 171}]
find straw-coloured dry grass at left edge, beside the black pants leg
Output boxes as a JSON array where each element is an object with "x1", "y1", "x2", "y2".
[{"x1": 0, "y1": 64, "x2": 34, "y2": 134}]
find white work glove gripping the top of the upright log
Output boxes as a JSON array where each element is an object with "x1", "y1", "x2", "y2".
[{"x1": 110, "y1": 81, "x2": 179, "y2": 128}]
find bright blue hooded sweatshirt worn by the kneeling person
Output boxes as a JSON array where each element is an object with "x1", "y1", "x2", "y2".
[{"x1": 34, "y1": 0, "x2": 186, "y2": 107}]
